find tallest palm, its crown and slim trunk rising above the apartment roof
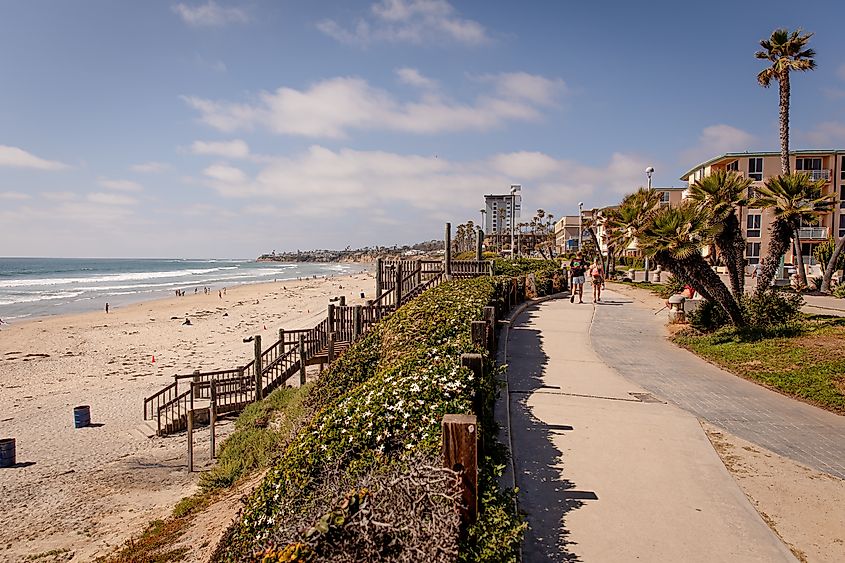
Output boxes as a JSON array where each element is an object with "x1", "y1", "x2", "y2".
[{"x1": 754, "y1": 29, "x2": 816, "y2": 174}]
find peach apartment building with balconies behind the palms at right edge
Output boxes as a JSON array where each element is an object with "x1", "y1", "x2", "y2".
[{"x1": 681, "y1": 150, "x2": 845, "y2": 265}]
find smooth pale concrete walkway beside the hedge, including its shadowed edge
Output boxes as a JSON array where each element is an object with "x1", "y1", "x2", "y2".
[{"x1": 498, "y1": 294, "x2": 795, "y2": 563}]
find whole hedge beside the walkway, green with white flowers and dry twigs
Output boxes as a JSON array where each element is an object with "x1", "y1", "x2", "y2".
[{"x1": 212, "y1": 261, "x2": 555, "y2": 562}]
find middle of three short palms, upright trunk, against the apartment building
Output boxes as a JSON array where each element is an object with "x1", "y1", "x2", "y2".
[{"x1": 689, "y1": 170, "x2": 752, "y2": 298}]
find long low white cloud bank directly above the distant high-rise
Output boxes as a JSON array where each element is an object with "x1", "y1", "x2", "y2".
[{"x1": 196, "y1": 145, "x2": 646, "y2": 218}]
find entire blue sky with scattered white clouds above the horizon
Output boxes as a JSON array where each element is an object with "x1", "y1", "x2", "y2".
[{"x1": 0, "y1": 0, "x2": 845, "y2": 257}]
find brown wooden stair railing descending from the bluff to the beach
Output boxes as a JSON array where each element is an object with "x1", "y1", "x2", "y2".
[{"x1": 144, "y1": 260, "x2": 491, "y2": 435}]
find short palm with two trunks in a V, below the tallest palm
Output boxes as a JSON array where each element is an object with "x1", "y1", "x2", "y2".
[{"x1": 750, "y1": 173, "x2": 833, "y2": 294}]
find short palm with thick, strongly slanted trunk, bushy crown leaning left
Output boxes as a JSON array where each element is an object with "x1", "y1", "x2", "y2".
[{"x1": 637, "y1": 201, "x2": 745, "y2": 327}]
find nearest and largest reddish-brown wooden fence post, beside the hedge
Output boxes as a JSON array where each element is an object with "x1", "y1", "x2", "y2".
[{"x1": 441, "y1": 414, "x2": 478, "y2": 526}]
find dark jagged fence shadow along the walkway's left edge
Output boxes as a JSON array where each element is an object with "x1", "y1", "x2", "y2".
[{"x1": 508, "y1": 310, "x2": 597, "y2": 563}]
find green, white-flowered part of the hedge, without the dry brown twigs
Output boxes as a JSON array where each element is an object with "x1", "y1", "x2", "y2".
[{"x1": 215, "y1": 278, "x2": 523, "y2": 561}]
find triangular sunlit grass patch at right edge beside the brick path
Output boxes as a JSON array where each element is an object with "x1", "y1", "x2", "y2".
[{"x1": 674, "y1": 317, "x2": 845, "y2": 414}]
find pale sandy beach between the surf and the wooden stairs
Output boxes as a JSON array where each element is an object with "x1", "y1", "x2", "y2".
[{"x1": 0, "y1": 273, "x2": 374, "y2": 561}]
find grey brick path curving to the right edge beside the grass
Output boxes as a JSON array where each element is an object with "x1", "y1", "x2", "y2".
[{"x1": 581, "y1": 291, "x2": 845, "y2": 479}]
